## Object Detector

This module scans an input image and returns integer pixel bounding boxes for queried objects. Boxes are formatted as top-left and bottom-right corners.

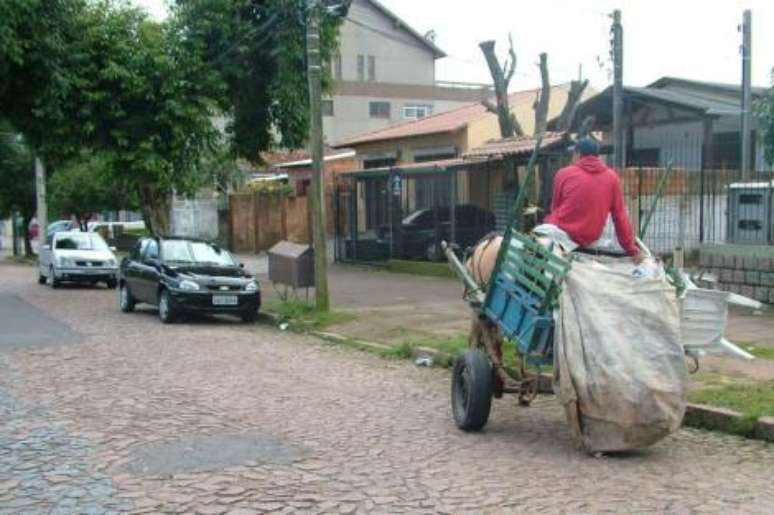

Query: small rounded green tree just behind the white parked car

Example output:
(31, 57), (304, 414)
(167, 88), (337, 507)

(46, 153), (137, 231)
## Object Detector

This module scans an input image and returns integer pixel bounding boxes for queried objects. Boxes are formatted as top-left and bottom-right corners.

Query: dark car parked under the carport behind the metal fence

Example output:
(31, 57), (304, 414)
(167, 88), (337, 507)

(378, 204), (496, 261)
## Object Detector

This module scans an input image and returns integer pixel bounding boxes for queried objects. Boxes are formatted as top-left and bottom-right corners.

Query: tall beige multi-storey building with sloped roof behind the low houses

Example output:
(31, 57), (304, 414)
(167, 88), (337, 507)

(323, 0), (491, 144)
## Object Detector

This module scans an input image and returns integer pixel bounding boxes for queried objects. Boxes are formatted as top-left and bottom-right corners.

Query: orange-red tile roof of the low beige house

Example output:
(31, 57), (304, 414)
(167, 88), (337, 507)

(334, 86), (556, 148)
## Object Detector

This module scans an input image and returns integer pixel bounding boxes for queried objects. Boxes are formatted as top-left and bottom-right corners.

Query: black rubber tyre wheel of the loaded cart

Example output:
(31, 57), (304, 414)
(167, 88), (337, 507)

(452, 349), (492, 431)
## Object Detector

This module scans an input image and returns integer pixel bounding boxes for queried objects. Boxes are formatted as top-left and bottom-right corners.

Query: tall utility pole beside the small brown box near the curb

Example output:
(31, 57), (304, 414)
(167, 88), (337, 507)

(306, 0), (330, 311)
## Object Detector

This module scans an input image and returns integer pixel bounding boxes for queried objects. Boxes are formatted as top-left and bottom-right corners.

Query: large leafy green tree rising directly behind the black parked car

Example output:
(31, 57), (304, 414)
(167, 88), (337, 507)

(55, 4), (218, 234)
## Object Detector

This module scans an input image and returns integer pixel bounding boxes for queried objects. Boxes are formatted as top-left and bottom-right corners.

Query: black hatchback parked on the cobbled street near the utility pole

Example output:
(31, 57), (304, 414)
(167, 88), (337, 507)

(119, 238), (261, 323)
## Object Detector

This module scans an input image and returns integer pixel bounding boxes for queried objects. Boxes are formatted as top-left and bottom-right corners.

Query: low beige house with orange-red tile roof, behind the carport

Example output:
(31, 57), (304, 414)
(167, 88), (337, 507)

(330, 84), (591, 232)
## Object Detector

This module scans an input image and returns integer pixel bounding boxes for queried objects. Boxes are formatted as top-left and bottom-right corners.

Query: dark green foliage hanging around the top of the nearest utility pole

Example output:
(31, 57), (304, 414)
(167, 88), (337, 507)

(173, 0), (349, 161)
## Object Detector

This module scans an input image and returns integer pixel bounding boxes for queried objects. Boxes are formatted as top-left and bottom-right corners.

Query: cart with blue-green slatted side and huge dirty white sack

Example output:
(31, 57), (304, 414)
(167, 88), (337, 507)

(442, 139), (760, 452)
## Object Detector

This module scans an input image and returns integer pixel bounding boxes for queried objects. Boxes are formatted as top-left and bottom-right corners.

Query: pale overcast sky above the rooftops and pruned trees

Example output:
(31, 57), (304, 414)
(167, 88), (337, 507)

(134, 0), (774, 89)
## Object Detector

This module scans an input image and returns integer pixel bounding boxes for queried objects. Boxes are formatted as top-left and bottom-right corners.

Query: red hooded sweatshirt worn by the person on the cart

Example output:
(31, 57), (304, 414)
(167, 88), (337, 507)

(544, 156), (639, 256)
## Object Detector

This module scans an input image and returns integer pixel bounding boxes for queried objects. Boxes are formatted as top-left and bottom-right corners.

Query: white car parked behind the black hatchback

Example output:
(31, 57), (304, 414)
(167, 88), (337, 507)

(38, 231), (118, 288)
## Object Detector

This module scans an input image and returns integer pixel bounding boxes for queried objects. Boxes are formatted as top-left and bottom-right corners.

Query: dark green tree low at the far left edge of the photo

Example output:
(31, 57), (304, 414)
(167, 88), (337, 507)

(0, 120), (36, 256)
